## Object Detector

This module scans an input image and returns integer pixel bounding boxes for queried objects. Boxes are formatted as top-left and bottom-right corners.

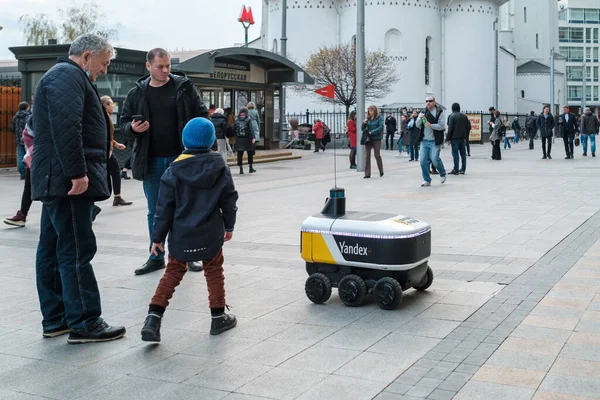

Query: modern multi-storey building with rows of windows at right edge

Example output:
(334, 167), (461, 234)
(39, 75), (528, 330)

(558, 0), (600, 115)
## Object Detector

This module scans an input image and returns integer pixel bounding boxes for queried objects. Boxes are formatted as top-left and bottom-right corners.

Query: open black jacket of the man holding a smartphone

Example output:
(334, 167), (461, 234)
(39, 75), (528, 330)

(120, 73), (208, 180)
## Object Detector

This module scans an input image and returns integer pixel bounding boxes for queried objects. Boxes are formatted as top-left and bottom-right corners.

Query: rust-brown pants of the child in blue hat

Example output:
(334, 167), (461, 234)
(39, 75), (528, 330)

(150, 249), (225, 308)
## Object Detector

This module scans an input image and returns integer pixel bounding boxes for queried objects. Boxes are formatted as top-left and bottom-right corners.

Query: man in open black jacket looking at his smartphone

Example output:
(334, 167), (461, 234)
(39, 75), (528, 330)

(121, 48), (208, 275)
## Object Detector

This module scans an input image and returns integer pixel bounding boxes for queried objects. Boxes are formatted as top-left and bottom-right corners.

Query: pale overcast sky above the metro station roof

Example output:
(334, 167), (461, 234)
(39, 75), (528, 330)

(0, 0), (262, 59)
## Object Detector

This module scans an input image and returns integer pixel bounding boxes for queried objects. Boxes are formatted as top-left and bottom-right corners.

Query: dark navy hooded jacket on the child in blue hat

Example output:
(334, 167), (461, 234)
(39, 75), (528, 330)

(152, 150), (238, 261)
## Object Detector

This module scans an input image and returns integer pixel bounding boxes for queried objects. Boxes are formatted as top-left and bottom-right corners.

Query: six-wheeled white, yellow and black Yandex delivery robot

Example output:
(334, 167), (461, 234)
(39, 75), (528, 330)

(300, 187), (433, 310)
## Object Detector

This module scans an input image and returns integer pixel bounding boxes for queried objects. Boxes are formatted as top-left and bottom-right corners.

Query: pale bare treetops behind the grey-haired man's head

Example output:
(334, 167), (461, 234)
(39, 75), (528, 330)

(19, 2), (119, 45)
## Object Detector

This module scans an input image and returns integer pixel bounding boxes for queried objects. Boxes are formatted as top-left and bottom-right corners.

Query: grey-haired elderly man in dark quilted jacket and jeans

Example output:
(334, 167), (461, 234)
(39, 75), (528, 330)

(31, 34), (125, 343)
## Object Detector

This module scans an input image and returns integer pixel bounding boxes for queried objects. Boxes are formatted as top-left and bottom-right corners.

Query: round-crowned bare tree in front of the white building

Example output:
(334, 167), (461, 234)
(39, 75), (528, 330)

(298, 44), (400, 115)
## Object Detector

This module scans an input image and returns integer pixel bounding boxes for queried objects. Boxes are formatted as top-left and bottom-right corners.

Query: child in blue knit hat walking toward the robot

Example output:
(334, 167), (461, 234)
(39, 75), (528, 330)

(142, 118), (238, 342)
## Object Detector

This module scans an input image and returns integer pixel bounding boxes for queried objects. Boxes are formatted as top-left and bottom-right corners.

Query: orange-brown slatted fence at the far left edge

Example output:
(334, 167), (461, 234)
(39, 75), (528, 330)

(0, 75), (21, 168)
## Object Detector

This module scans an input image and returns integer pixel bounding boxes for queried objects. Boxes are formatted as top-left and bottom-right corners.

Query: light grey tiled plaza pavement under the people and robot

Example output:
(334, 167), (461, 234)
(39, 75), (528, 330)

(0, 139), (600, 400)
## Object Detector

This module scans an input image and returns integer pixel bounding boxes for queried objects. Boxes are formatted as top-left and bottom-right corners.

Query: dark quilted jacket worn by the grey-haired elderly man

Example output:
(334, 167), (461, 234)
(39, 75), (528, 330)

(31, 57), (111, 201)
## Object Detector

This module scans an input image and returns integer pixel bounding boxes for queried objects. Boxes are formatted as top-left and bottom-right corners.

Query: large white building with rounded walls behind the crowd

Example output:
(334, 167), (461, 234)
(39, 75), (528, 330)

(252, 0), (566, 113)
